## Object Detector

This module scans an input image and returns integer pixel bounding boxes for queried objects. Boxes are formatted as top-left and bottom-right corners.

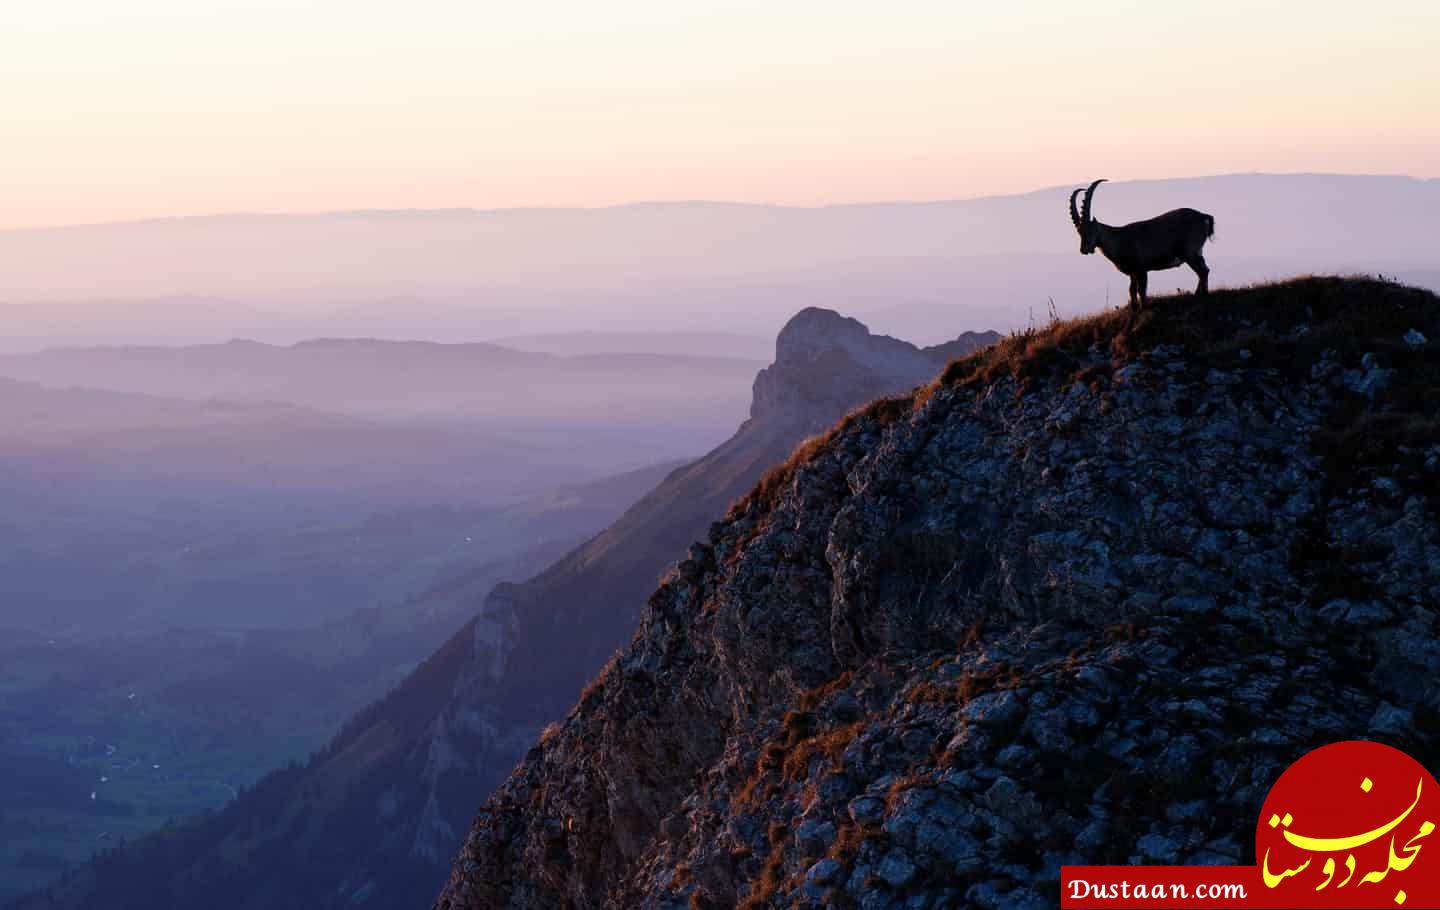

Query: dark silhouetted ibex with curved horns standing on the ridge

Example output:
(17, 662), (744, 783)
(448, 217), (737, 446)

(1070, 179), (1215, 307)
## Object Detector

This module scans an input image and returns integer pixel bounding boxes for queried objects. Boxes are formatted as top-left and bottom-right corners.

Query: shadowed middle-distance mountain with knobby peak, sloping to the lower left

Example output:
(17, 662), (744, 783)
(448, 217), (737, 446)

(23, 308), (996, 910)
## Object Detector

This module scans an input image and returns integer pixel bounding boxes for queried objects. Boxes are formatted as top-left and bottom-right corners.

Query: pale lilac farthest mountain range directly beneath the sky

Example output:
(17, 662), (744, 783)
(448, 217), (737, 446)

(0, 174), (1440, 351)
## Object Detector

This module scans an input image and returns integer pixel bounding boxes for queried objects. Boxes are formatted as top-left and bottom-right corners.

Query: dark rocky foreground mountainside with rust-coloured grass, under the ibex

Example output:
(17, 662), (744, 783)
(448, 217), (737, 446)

(438, 279), (1440, 910)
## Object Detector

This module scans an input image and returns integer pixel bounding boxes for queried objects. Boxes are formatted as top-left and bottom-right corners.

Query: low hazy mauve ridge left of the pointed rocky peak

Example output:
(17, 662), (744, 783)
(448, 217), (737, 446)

(0, 338), (763, 428)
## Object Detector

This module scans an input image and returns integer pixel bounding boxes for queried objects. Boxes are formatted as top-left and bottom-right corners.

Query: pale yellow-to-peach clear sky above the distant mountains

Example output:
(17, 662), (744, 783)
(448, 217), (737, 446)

(0, 0), (1440, 228)
